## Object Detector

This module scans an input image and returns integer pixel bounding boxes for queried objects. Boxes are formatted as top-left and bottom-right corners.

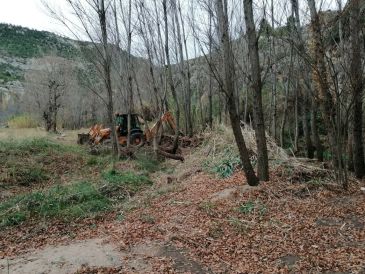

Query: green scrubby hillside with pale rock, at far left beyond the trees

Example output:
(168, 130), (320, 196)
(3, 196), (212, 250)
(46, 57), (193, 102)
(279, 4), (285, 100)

(0, 24), (81, 121)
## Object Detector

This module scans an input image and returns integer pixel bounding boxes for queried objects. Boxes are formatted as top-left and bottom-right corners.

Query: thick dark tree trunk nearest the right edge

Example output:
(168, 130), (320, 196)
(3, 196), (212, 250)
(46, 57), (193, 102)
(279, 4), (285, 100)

(350, 0), (365, 179)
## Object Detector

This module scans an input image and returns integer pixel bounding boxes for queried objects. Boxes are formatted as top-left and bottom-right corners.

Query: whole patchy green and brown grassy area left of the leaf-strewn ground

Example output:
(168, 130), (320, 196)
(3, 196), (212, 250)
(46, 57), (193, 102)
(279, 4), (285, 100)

(0, 135), (155, 227)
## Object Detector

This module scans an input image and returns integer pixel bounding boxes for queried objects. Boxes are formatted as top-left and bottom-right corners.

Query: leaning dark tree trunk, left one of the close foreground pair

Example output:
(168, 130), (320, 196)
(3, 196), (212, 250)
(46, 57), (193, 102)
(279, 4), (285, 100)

(216, 0), (259, 186)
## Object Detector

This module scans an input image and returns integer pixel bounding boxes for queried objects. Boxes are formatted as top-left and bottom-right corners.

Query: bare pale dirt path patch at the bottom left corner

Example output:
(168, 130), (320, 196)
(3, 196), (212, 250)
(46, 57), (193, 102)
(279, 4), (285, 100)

(0, 238), (212, 274)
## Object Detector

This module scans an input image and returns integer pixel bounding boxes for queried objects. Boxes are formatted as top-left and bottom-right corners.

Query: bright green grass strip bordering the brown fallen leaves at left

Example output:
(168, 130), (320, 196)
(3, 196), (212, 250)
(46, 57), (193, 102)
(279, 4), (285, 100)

(0, 170), (152, 227)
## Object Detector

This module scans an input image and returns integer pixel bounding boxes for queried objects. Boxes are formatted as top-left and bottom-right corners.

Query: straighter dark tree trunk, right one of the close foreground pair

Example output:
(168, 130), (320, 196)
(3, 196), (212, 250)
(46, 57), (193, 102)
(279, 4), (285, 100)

(244, 0), (269, 181)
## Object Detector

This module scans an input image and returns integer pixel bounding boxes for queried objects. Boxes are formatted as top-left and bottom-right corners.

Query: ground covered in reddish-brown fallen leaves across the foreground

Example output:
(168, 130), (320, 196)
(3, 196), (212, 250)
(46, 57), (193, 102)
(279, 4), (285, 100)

(0, 165), (365, 273)
